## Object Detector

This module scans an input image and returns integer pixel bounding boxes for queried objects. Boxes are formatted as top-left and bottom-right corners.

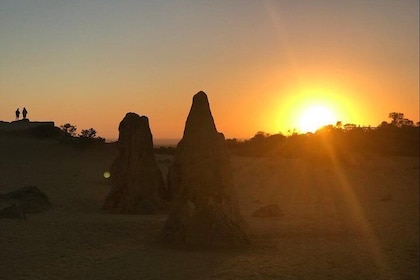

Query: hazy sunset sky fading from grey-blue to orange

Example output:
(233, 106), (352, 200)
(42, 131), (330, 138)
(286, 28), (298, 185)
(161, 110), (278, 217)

(0, 0), (419, 138)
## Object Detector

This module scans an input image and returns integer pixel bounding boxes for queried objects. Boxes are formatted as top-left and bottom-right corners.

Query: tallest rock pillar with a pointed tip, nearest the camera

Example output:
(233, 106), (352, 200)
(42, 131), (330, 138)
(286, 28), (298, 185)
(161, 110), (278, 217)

(161, 91), (249, 247)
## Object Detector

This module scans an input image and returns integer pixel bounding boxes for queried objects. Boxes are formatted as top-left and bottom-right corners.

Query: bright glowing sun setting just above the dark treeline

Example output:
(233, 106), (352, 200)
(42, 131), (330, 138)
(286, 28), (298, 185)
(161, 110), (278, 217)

(299, 105), (337, 133)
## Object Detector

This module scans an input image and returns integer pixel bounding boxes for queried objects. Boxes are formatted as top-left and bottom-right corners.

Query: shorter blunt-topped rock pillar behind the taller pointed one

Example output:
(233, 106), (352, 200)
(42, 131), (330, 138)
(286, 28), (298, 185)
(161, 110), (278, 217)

(103, 113), (165, 214)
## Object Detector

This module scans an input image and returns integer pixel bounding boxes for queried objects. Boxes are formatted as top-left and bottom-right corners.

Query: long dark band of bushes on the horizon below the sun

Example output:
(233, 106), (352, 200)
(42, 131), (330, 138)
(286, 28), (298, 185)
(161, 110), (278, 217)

(226, 113), (420, 160)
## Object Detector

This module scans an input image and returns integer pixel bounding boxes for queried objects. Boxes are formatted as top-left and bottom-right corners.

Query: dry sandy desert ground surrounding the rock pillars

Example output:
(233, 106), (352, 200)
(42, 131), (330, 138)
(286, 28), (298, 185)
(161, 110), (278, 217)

(0, 137), (419, 280)
